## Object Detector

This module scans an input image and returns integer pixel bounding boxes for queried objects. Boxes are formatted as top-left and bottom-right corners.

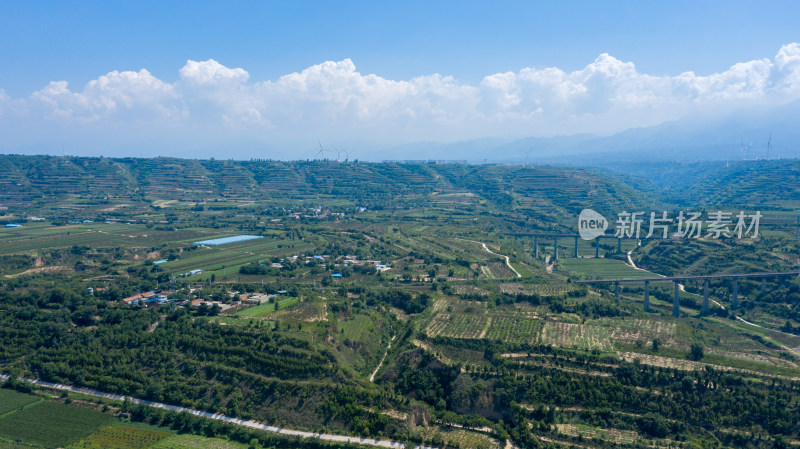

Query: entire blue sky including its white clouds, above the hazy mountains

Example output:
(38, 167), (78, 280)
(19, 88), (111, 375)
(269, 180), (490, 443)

(0, 1), (800, 159)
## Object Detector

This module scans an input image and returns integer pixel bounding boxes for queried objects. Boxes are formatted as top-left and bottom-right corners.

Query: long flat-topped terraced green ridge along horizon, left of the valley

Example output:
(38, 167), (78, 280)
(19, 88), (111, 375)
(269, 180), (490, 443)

(0, 156), (645, 220)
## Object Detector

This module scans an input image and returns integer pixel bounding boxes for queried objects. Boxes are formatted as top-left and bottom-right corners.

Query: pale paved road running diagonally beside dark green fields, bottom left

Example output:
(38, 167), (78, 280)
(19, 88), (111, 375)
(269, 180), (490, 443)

(0, 374), (438, 449)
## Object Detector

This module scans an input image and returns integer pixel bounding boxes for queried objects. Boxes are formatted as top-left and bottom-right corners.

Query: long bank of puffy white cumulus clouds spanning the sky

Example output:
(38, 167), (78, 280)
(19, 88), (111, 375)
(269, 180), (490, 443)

(0, 43), (800, 150)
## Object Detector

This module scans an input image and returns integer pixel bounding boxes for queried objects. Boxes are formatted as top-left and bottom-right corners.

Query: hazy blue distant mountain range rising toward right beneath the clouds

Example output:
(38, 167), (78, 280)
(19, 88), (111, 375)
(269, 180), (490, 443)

(384, 101), (800, 166)
